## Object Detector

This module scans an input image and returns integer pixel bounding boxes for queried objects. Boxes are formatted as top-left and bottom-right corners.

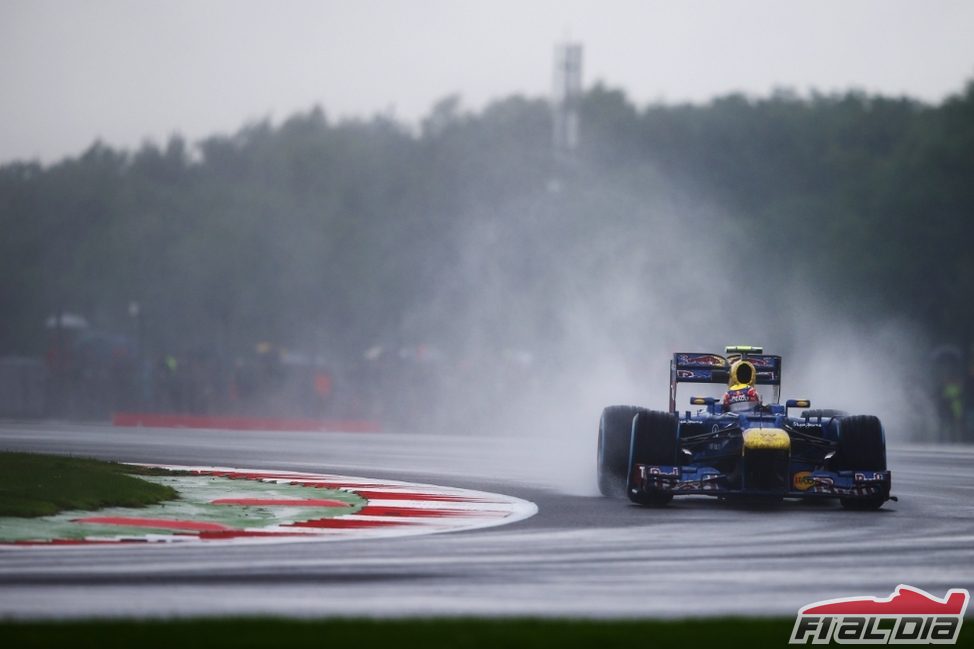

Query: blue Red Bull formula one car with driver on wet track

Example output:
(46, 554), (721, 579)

(598, 346), (896, 509)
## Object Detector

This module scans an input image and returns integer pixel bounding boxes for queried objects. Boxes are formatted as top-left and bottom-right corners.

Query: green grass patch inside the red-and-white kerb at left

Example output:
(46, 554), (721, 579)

(0, 452), (177, 518)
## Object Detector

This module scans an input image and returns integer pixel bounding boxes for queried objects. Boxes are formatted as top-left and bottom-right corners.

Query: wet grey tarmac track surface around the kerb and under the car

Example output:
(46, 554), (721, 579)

(0, 423), (974, 619)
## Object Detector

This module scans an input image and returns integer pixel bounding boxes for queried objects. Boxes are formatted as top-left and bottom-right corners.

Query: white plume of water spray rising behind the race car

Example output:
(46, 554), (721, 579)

(388, 152), (930, 493)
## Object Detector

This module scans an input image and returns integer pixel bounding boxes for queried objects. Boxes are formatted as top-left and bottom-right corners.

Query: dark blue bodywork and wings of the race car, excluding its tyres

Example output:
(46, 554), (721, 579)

(626, 347), (891, 509)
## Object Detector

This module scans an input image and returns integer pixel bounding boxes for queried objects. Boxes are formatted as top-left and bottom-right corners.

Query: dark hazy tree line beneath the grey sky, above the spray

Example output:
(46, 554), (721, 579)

(0, 83), (974, 426)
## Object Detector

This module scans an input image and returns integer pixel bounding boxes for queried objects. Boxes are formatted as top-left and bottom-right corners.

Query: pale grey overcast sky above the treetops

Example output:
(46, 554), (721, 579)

(0, 0), (974, 162)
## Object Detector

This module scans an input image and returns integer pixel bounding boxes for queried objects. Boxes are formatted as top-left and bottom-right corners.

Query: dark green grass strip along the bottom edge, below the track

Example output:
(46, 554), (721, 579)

(0, 618), (793, 649)
